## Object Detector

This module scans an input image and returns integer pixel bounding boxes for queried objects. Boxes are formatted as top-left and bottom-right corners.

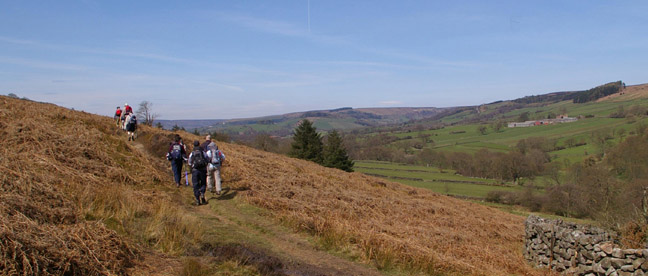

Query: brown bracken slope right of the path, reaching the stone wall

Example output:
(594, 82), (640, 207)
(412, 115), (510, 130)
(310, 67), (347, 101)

(221, 138), (543, 275)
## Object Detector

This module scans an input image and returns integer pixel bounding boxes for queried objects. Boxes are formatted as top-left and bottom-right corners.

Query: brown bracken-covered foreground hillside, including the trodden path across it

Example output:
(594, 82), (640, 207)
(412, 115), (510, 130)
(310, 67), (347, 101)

(0, 97), (544, 275)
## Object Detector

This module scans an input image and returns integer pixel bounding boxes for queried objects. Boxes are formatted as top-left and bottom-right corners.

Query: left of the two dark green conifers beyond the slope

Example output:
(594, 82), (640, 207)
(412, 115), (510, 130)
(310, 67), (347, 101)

(289, 119), (322, 163)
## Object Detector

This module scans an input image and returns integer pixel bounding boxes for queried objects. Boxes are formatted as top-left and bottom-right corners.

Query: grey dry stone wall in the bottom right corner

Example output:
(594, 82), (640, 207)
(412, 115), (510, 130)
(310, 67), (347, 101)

(524, 215), (648, 276)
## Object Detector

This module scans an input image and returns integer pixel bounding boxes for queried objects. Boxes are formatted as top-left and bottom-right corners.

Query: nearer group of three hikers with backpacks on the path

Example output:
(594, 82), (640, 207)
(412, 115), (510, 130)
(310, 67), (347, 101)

(166, 134), (225, 205)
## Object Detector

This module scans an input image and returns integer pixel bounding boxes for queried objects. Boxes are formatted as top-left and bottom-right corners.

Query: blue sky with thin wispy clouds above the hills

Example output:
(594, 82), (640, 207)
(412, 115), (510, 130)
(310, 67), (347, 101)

(0, 0), (648, 119)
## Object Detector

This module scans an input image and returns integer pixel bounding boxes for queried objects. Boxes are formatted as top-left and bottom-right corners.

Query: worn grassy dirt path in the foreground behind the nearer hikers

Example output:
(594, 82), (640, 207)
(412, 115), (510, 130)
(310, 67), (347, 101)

(194, 189), (382, 276)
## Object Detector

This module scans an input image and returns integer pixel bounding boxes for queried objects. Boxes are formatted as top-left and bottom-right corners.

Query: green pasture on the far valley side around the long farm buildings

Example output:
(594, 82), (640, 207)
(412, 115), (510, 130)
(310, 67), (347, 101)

(388, 99), (648, 163)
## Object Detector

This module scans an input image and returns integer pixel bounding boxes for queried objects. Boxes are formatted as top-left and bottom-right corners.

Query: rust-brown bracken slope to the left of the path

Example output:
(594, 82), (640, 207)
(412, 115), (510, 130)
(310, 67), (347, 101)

(0, 96), (200, 275)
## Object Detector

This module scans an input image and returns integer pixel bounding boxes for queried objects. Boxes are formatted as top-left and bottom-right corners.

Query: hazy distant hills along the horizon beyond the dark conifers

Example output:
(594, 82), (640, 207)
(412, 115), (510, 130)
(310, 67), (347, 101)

(160, 107), (446, 136)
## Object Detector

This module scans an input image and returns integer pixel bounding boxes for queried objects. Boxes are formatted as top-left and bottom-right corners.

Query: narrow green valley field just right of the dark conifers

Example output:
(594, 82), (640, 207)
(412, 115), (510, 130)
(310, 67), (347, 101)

(354, 161), (523, 199)
